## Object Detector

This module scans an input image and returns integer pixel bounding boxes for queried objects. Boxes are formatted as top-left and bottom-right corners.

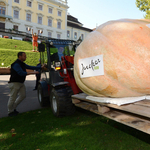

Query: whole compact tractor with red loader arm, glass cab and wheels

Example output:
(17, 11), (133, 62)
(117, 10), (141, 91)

(38, 39), (81, 116)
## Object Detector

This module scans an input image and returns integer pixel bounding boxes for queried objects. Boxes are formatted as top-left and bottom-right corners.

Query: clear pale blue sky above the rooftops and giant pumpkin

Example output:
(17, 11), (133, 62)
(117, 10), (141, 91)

(68, 0), (144, 29)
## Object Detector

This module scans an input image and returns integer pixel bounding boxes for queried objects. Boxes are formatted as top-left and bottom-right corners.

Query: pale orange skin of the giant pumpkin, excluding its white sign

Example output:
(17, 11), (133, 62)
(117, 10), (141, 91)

(74, 19), (150, 97)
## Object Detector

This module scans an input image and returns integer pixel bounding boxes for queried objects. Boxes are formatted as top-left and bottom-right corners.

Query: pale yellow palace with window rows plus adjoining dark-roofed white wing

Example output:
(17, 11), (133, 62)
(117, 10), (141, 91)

(0, 0), (91, 40)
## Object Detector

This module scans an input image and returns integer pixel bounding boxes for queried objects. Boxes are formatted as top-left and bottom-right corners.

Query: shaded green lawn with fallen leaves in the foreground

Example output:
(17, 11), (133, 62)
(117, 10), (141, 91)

(0, 108), (150, 150)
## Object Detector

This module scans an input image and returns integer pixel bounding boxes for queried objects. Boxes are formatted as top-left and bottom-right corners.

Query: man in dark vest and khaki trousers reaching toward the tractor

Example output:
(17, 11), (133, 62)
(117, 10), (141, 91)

(7, 52), (44, 116)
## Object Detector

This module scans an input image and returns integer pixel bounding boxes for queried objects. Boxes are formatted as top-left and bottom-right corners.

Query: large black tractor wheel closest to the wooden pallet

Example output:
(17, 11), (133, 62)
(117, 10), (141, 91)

(50, 87), (75, 117)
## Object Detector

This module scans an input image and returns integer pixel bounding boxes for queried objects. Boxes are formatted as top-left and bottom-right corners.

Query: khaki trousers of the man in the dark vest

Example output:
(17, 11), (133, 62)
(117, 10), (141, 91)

(7, 82), (26, 114)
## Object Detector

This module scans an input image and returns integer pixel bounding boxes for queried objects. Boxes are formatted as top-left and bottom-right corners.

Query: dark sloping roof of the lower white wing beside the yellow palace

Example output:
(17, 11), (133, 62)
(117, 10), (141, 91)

(67, 15), (93, 32)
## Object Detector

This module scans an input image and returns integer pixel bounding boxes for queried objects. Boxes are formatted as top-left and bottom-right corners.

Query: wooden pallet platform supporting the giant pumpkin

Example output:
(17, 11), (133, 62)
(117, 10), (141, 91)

(72, 93), (150, 134)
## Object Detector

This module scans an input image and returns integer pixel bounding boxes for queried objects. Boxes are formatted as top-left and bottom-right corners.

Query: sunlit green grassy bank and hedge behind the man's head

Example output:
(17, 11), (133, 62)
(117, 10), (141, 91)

(0, 38), (40, 67)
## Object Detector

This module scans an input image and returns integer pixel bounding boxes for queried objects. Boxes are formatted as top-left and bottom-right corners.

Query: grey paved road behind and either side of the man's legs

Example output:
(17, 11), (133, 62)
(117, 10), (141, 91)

(0, 75), (42, 118)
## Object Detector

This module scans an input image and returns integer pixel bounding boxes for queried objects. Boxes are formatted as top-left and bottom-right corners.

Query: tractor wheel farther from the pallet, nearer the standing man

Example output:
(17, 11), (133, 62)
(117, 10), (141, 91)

(37, 84), (50, 107)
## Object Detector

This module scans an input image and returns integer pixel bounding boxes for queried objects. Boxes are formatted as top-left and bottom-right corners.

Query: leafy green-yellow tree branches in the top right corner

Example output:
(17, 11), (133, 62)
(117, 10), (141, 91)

(136, 0), (150, 19)
